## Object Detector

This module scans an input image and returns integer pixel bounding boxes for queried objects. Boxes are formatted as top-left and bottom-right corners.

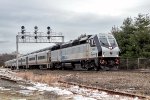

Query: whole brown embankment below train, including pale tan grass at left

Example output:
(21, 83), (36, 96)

(18, 70), (150, 96)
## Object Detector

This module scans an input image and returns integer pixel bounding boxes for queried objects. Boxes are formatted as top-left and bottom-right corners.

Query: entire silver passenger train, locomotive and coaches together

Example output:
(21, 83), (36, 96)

(5, 33), (120, 70)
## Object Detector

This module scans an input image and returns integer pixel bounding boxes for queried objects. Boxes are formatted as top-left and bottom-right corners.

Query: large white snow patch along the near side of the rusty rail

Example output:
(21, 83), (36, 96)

(67, 86), (139, 100)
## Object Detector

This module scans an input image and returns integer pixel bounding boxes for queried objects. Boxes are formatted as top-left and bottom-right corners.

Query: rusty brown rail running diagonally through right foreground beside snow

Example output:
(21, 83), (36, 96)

(58, 81), (150, 100)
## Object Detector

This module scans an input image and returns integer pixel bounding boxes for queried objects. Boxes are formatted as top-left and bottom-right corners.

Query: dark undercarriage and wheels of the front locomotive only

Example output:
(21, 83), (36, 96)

(46, 58), (119, 71)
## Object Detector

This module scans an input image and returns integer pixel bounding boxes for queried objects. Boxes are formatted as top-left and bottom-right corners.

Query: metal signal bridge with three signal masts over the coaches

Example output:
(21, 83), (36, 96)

(16, 26), (64, 69)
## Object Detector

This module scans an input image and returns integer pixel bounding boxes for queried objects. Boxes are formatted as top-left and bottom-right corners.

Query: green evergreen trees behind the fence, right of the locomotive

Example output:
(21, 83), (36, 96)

(111, 14), (150, 58)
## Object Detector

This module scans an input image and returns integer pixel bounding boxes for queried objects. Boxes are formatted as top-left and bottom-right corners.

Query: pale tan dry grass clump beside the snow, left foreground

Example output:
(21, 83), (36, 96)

(17, 72), (59, 85)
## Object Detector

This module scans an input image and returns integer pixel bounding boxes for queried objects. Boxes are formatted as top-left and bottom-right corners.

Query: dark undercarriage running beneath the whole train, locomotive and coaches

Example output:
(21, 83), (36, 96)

(9, 57), (119, 71)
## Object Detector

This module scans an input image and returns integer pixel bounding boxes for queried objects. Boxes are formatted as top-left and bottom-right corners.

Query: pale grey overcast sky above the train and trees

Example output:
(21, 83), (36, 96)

(0, 0), (150, 54)
